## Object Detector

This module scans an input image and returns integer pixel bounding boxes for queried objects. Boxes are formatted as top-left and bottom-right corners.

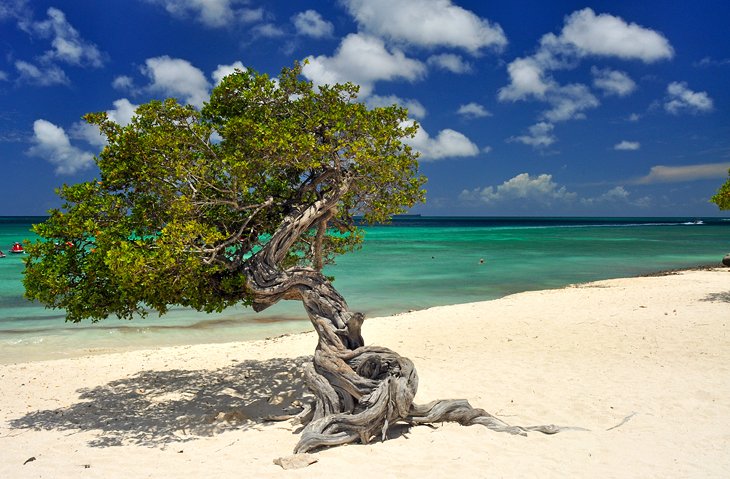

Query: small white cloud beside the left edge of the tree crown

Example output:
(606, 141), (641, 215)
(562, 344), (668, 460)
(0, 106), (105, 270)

(28, 120), (94, 175)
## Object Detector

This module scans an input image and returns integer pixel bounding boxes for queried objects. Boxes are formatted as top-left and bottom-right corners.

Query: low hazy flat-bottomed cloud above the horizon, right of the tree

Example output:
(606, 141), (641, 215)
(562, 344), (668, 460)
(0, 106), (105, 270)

(459, 173), (577, 206)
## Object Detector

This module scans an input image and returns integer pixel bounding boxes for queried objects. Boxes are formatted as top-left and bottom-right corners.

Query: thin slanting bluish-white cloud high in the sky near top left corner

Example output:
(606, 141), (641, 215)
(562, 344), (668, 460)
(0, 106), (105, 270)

(21, 7), (104, 67)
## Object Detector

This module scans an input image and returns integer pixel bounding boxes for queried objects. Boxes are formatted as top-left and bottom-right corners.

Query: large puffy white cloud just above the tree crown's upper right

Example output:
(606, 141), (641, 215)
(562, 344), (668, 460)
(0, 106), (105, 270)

(302, 33), (426, 96)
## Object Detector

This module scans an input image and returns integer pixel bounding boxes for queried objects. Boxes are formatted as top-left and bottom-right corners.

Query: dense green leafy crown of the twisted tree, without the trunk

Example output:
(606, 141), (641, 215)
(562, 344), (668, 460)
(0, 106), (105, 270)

(24, 65), (425, 321)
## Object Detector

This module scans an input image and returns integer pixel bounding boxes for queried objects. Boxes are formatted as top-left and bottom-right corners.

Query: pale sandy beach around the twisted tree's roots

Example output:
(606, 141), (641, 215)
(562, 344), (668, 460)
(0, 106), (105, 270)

(0, 269), (730, 478)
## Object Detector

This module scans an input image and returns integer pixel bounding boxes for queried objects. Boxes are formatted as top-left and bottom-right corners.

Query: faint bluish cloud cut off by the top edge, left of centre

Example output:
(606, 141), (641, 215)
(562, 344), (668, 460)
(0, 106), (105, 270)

(142, 0), (264, 28)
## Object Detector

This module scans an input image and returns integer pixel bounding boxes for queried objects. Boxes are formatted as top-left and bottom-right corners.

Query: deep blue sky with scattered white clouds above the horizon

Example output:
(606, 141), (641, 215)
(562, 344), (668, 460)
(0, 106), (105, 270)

(0, 0), (730, 216)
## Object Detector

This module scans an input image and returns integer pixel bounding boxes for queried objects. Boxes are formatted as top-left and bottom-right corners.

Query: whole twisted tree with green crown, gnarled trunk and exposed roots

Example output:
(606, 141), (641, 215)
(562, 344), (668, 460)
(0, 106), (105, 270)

(24, 65), (559, 452)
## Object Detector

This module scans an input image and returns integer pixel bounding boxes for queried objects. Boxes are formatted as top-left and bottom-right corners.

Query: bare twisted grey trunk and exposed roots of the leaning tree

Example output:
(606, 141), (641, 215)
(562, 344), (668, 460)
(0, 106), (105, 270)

(246, 184), (560, 453)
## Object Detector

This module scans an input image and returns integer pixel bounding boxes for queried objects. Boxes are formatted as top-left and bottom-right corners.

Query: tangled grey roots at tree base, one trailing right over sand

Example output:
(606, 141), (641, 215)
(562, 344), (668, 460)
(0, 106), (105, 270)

(294, 346), (567, 453)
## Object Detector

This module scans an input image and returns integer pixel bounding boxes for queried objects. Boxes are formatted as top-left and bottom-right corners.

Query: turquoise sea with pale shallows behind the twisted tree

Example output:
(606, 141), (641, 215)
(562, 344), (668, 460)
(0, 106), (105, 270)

(0, 215), (730, 364)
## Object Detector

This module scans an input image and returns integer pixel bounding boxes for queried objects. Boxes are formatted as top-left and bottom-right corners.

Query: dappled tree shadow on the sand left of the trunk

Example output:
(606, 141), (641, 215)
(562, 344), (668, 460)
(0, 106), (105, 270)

(10, 356), (312, 447)
